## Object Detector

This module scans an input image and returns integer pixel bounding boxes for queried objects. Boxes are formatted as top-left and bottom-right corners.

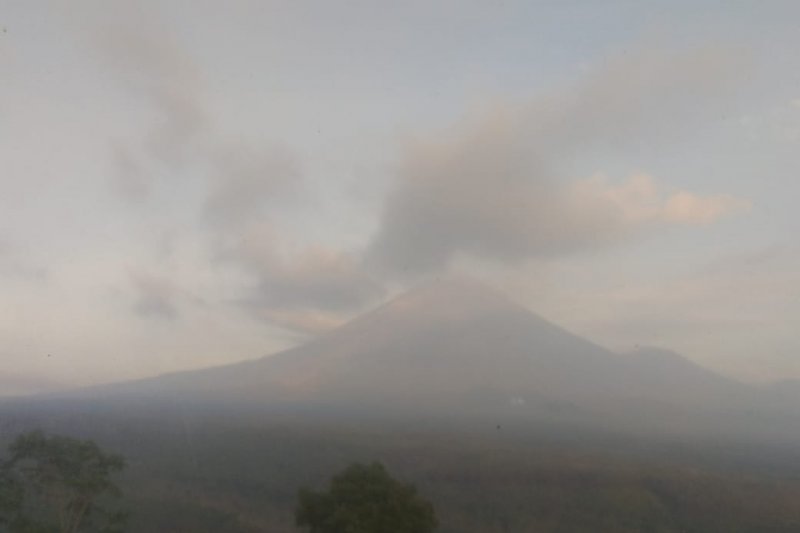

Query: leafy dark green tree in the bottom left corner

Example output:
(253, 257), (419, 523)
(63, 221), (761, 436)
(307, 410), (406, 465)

(0, 431), (125, 533)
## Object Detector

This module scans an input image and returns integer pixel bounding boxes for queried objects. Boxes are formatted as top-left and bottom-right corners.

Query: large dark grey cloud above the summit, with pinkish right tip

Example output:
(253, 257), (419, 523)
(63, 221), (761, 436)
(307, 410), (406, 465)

(367, 50), (746, 275)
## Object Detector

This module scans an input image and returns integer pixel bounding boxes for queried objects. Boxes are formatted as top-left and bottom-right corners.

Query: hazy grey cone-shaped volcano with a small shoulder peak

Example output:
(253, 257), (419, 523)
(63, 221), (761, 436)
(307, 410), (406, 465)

(51, 280), (744, 420)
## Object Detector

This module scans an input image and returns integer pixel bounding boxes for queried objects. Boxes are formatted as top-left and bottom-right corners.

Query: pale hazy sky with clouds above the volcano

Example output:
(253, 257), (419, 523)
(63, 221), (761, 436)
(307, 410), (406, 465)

(0, 0), (800, 394)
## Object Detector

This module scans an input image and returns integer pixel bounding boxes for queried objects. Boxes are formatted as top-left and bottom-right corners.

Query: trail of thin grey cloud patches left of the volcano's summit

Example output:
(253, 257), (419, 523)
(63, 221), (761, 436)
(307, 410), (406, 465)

(92, 17), (381, 331)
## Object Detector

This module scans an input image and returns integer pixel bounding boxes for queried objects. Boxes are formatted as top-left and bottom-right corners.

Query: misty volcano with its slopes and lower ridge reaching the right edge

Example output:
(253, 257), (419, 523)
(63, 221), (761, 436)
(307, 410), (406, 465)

(25, 279), (800, 443)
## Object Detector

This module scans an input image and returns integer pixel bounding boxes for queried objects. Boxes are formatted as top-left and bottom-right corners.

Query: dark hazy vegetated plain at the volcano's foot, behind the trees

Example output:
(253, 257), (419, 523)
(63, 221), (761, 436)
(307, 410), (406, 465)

(0, 415), (800, 533)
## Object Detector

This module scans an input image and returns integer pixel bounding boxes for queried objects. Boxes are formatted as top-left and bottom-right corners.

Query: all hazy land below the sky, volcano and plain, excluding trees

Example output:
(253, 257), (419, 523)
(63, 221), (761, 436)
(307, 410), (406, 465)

(0, 278), (800, 533)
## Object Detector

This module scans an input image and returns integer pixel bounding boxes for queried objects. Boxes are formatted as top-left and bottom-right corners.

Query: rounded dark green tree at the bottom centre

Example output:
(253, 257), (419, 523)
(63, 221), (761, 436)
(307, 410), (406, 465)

(295, 463), (437, 533)
